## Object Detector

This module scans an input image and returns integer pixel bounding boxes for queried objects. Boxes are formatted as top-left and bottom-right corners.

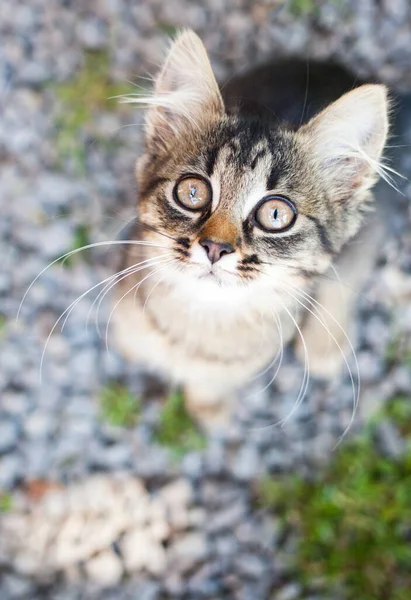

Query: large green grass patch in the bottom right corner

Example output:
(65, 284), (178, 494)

(259, 398), (411, 600)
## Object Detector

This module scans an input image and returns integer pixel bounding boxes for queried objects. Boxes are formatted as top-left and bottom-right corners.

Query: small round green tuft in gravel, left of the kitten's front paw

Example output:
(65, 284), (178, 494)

(100, 383), (141, 427)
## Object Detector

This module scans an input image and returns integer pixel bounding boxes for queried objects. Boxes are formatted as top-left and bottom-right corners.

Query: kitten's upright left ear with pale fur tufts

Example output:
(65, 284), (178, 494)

(142, 30), (224, 148)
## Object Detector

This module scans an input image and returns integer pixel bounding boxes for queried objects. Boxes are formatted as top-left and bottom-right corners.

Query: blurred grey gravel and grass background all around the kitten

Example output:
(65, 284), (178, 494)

(0, 0), (411, 600)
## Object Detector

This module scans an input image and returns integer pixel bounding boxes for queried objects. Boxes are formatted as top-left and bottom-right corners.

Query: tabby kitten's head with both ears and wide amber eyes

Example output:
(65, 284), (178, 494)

(128, 31), (388, 298)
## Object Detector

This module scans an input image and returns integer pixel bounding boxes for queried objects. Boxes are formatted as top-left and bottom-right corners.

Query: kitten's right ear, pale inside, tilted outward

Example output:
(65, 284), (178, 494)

(300, 84), (389, 203)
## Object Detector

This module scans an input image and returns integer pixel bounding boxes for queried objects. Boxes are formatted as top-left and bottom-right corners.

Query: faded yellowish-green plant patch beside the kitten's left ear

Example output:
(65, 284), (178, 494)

(53, 51), (135, 173)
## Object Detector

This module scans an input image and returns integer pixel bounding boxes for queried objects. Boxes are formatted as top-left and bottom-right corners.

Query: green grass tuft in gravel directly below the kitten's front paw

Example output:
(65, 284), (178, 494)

(154, 391), (205, 459)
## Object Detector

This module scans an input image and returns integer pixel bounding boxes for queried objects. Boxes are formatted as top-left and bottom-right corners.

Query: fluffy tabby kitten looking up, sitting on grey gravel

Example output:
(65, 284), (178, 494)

(113, 31), (388, 428)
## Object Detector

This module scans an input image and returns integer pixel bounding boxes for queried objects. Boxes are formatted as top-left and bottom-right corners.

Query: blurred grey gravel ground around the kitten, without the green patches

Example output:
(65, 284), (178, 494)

(0, 0), (411, 600)
